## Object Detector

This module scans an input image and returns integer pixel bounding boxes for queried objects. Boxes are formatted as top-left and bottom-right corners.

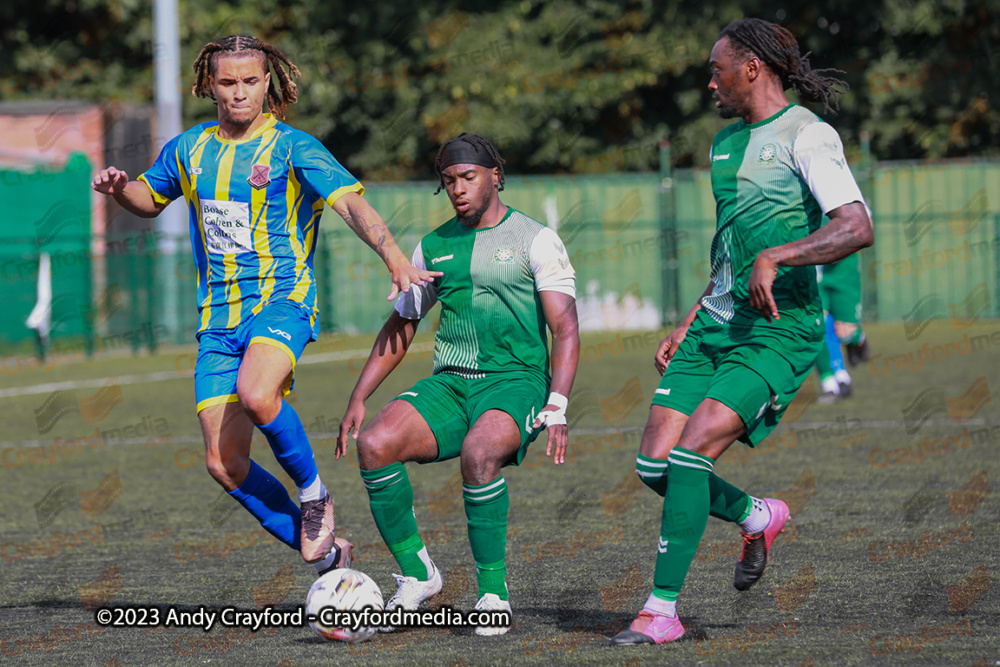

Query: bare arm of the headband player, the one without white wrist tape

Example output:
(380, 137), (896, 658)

(335, 311), (420, 459)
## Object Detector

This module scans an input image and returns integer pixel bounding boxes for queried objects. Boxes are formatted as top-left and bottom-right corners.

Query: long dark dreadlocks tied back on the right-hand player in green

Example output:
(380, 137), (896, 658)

(719, 18), (850, 114)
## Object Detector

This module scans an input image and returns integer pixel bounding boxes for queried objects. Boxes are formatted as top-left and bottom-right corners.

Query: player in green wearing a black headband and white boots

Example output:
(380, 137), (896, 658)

(337, 133), (580, 635)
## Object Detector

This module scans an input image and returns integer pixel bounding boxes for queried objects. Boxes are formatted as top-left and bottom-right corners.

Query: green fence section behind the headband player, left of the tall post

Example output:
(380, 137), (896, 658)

(340, 174), (663, 331)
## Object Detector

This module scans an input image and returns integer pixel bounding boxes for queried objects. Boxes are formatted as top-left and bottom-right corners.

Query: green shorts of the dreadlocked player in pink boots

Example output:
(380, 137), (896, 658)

(653, 310), (824, 447)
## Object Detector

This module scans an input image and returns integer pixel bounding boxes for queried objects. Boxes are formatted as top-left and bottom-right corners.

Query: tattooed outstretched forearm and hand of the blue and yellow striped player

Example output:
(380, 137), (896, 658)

(333, 192), (444, 301)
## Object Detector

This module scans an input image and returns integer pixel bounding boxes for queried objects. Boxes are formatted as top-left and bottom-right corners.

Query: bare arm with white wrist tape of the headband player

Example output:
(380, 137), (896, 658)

(532, 290), (580, 464)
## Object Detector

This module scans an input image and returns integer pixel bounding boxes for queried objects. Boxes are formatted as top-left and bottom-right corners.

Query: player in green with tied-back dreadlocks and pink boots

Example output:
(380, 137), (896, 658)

(611, 19), (873, 644)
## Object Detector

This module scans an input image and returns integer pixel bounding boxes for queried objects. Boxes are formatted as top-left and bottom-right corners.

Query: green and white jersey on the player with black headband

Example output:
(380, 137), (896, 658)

(396, 208), (576, 381)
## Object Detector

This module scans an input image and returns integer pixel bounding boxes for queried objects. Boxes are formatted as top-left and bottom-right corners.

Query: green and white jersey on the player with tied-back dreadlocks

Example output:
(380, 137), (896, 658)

(702, 104), (864, 326)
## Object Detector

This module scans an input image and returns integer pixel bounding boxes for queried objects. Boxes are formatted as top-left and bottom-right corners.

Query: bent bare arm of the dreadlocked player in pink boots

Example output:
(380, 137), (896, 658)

(748, 201), (875, 322)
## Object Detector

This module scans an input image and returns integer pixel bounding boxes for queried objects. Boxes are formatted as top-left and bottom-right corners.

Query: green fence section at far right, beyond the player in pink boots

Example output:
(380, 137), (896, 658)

(862, 159), (1000, 320)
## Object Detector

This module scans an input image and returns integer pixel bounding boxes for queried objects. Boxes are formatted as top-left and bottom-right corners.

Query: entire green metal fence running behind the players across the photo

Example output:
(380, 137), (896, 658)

(0, 155), (1000, 360)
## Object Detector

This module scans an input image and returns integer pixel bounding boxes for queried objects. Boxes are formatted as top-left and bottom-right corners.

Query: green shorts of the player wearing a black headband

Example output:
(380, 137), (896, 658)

(396, 371), (549, 465)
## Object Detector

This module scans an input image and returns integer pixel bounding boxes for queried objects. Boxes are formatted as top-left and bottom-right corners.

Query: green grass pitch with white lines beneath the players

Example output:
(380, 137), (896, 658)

(0, 322), (1000, 666)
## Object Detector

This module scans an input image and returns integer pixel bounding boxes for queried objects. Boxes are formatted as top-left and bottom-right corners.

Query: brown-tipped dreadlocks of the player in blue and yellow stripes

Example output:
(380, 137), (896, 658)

(191, 35), (300, 120)
